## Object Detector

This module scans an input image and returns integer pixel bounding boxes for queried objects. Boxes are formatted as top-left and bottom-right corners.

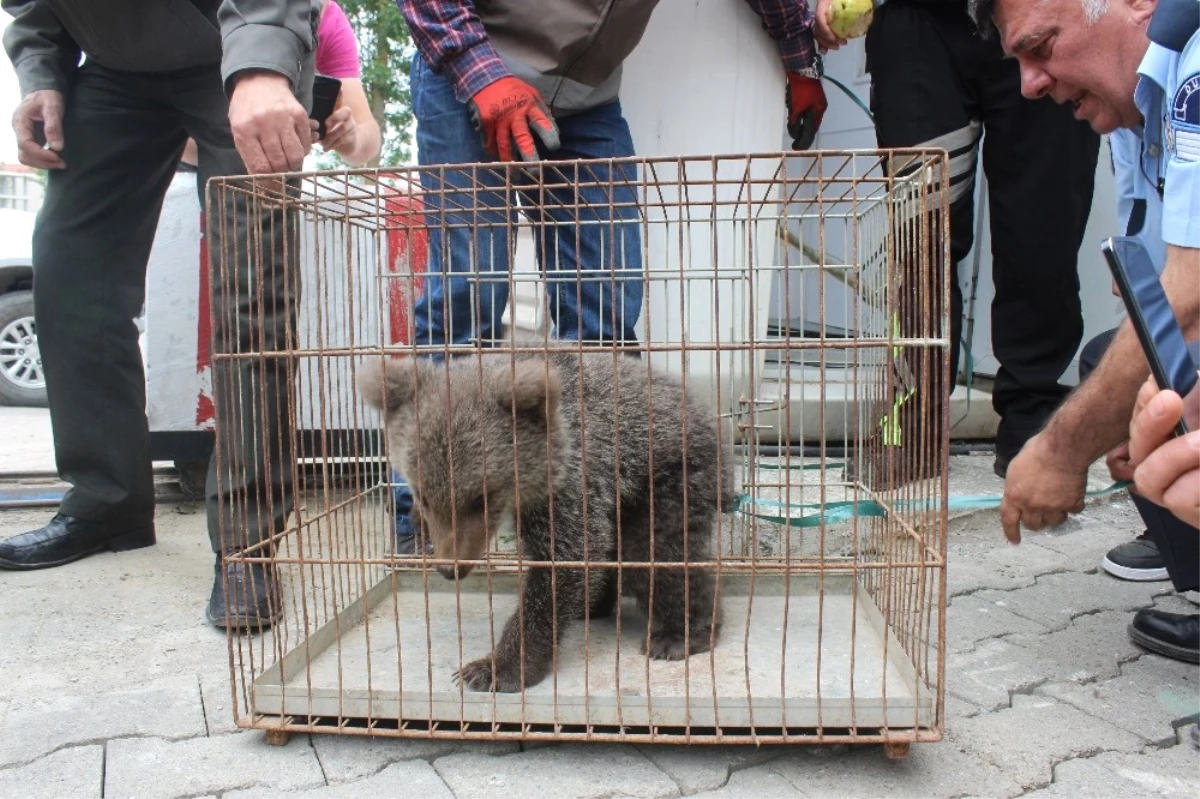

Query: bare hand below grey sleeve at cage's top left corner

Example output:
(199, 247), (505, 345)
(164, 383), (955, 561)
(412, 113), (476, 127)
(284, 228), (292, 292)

(229, 72), (313, 175)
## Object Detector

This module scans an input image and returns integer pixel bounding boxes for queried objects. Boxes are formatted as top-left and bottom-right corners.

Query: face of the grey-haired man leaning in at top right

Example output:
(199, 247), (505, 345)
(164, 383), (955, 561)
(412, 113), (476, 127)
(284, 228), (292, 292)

(995, 0), (1156, 134)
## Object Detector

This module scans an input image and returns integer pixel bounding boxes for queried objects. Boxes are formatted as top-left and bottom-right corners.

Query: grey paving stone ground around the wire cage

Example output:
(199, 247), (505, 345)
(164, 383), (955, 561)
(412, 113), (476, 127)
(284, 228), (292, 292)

(0, 457), (1200, 799)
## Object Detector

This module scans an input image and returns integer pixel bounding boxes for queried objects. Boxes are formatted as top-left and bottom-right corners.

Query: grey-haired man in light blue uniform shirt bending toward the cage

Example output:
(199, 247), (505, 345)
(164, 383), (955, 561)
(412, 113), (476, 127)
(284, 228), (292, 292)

(973, 0), (1200, 662)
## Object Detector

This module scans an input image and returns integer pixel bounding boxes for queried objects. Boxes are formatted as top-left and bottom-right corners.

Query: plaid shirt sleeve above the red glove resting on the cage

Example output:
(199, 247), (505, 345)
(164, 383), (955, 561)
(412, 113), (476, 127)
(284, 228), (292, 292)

(396, 0), (511, 103)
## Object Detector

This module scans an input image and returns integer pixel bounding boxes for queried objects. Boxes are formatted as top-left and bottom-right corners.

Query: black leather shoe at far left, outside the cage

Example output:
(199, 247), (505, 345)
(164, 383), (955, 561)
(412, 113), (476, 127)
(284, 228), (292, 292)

(0, 513), (155, 569)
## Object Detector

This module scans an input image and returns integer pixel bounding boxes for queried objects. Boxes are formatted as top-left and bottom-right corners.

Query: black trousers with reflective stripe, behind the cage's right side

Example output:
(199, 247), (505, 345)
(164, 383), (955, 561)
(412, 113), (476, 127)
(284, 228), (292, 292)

(865, 0), (1100, 456)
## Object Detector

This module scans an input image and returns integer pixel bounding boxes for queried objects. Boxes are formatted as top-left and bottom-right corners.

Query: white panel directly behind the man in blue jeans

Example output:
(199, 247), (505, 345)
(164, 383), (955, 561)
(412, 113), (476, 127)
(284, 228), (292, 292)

(504, 0), (786, 422)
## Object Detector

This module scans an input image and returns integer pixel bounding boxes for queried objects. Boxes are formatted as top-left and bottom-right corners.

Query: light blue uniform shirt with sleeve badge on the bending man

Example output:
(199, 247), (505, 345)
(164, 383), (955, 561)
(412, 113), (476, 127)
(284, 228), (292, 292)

(1134, 19), (1200, 247)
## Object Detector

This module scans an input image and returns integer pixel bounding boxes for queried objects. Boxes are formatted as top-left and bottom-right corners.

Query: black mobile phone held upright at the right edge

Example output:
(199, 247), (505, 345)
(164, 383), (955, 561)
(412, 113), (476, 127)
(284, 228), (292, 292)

(1100, 236), (1196, 435)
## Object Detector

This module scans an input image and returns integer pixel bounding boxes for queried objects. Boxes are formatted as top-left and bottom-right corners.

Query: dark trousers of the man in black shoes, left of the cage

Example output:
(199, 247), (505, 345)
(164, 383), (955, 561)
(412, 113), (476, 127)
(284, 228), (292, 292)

(39, 61), (312, 552)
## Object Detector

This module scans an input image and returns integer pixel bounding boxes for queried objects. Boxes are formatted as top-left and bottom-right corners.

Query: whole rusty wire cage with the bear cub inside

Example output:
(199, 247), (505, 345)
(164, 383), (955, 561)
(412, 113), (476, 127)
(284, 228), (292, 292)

(206, 150), (949, 751)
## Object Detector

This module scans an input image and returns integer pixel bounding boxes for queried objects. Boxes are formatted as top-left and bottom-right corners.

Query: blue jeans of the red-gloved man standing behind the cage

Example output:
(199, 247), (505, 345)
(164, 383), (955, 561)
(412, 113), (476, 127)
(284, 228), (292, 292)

(392, 53), (643, 535)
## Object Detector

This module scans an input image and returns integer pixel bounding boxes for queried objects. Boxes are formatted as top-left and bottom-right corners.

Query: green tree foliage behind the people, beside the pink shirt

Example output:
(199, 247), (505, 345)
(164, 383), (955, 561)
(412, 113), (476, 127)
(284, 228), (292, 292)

(318, 0), (414, 168)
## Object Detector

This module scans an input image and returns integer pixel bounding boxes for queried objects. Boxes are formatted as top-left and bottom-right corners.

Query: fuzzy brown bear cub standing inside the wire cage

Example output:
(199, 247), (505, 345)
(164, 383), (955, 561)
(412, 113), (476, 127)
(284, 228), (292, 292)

(358, 348), (734, 691)
